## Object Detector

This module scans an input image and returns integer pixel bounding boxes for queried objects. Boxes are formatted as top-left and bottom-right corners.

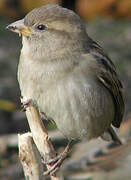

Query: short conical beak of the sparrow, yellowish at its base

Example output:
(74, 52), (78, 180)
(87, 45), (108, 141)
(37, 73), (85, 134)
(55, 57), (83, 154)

(6, 19), (32, 36)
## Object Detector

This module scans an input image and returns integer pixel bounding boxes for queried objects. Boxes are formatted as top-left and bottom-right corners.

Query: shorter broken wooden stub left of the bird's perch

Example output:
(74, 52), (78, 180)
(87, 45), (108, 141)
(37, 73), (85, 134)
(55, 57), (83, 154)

(18, 133), (45, 180)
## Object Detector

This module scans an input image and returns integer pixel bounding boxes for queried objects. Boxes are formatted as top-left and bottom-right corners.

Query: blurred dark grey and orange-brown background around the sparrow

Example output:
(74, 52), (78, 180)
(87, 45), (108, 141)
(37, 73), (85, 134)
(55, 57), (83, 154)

(0, 0), (131, 180)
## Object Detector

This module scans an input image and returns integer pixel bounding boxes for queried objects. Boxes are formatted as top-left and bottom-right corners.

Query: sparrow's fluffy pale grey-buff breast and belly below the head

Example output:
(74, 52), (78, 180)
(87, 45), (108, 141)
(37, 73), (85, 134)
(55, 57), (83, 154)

(18, 46), (114, 139)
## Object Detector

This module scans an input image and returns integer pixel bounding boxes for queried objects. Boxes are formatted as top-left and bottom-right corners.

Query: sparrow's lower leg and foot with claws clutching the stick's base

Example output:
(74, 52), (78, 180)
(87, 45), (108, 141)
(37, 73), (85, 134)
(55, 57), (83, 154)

(44, 140), (73, 175)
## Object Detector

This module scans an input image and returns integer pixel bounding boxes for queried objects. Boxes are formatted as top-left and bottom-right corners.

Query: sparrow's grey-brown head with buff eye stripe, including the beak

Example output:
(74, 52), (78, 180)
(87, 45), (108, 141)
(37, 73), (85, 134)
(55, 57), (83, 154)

(7, 4), (87, 58)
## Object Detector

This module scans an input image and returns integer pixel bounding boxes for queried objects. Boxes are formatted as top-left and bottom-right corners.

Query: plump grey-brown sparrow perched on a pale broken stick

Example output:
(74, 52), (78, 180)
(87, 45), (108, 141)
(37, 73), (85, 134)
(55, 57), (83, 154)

(7, 4), (125, 175)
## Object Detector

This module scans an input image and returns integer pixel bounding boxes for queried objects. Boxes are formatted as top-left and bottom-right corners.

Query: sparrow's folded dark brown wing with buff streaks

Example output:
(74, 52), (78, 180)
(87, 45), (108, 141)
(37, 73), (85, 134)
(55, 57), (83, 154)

(89, 40), (125, 128)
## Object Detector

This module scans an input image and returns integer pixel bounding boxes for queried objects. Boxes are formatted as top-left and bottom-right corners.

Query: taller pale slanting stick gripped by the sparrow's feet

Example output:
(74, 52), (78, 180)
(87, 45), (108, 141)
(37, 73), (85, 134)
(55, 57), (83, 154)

(22, 99), (63, 180)
